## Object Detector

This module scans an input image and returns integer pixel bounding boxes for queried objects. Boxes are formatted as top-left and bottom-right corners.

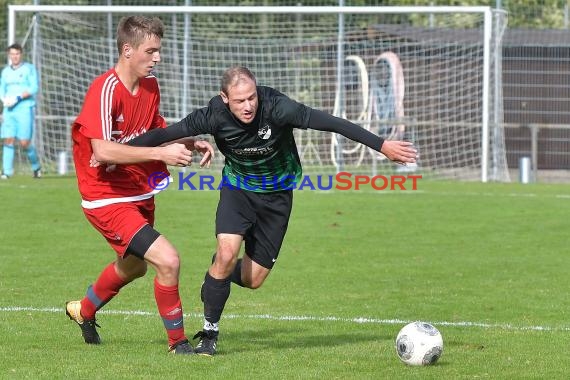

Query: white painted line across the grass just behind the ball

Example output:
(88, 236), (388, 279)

(0, 306), (570, 331)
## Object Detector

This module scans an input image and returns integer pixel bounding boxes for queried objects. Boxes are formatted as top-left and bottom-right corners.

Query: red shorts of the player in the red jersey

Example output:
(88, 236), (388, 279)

(83, 198), (154, 257)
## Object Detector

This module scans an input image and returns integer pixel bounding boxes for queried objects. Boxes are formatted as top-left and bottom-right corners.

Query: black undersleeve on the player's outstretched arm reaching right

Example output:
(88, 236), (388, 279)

(308, 109), (384, 152)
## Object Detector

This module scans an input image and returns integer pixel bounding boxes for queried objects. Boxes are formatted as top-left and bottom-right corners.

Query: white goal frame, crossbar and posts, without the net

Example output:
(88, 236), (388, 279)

(8, 5), (502, 182)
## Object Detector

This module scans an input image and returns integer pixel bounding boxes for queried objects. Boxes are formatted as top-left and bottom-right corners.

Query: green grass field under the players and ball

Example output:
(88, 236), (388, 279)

(0, 176), (570, 379)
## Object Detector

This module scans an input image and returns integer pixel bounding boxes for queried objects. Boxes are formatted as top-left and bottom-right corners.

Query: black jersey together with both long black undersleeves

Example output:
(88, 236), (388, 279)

(128, 86), (384, 193)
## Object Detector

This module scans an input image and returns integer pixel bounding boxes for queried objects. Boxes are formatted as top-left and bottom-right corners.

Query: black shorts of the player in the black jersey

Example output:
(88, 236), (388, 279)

(216, 186), (293, 269)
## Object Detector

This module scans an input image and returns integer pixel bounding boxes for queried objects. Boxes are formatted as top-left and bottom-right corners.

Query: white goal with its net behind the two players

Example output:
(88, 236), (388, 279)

(9, 6), (509, 181)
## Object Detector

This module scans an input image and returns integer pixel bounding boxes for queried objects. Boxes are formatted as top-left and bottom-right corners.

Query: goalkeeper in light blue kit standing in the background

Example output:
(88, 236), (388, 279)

(0, 44), (42, 179)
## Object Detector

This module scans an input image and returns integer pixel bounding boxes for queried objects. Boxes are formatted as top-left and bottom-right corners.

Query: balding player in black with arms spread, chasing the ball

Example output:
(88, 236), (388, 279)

(129, 67), (417, 356)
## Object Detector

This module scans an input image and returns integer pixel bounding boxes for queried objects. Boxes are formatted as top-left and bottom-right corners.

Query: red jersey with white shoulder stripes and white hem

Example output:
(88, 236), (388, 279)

(71, 69), (168, 208)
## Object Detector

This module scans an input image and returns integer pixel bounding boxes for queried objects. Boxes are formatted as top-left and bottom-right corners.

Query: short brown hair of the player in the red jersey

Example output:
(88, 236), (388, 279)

(117, 16), (164, 54)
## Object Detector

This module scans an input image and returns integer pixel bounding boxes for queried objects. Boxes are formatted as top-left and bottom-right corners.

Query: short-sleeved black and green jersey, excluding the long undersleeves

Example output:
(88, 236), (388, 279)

(177, 86), (311, 192)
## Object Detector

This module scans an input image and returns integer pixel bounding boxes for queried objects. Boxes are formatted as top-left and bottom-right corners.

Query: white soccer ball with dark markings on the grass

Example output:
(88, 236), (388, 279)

(396, 321), (443, 365)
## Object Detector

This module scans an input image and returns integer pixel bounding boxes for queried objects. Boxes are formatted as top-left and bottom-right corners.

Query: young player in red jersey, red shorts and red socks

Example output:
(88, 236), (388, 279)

(66, 16), (213, 354)
